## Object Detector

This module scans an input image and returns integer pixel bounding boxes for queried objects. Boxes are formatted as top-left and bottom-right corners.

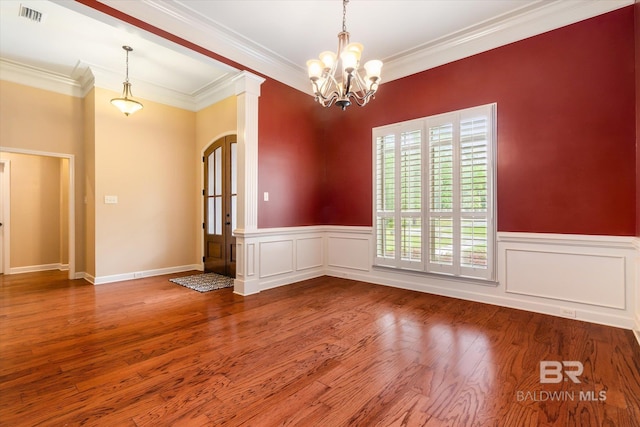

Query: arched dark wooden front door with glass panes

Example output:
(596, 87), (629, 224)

(203, 135), (238, 277)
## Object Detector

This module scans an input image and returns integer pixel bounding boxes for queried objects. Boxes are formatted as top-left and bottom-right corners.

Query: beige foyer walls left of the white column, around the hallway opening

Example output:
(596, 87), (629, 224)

(0, 81), (236, 278)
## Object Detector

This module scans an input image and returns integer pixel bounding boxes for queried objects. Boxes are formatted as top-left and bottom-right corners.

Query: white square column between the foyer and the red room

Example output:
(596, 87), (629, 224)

(233, 71), (264, 295)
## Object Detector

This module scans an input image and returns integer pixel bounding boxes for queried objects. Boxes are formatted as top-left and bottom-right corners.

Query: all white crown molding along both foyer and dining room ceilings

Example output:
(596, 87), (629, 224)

(5, 0), (634, 103)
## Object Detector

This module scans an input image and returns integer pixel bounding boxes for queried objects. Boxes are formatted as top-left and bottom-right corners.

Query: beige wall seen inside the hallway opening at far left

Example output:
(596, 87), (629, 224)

(0, 153), (69, 270)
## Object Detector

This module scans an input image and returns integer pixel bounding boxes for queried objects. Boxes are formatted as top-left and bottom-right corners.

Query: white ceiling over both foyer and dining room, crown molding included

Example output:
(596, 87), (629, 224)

(0, 0), (633, 111)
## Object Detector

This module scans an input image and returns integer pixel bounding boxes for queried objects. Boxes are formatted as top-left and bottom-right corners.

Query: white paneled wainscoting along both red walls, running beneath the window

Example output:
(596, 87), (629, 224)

(235, 226), (640, 336)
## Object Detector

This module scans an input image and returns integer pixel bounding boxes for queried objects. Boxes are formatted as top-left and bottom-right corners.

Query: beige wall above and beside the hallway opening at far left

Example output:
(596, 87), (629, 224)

(0, 81), (84, 271)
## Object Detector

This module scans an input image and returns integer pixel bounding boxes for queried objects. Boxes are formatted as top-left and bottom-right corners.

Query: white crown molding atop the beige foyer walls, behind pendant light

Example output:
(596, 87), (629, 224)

(0, 58), (238, 112)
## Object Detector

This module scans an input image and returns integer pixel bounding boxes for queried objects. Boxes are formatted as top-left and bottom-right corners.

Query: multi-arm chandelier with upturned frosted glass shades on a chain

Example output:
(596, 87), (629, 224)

(307, 0), (382, 110)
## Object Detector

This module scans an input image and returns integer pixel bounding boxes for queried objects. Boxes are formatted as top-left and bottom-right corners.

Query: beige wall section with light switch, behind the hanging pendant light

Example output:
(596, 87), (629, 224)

(95, 88), (198, 277)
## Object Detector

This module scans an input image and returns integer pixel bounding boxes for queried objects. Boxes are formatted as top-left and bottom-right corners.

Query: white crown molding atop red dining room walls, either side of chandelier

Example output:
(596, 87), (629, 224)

(102, 0), (634, 93)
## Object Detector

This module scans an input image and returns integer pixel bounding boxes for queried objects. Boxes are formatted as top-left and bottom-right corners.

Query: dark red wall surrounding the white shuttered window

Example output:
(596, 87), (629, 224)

(322, 5), (638, 235)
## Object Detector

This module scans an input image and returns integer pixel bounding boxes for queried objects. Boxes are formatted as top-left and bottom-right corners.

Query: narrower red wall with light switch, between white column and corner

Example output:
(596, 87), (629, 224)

(258, 79), (325, 228)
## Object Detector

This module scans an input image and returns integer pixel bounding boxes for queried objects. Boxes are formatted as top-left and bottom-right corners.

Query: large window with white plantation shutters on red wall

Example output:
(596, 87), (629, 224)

(373, 104), (496, 280)
